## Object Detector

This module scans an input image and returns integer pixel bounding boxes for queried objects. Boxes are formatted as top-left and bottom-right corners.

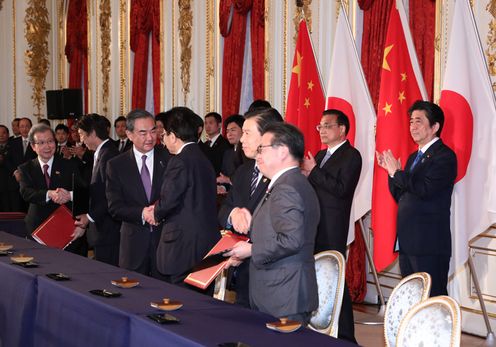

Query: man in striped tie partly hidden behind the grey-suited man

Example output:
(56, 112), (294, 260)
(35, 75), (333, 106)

(219, 108), (283, 307)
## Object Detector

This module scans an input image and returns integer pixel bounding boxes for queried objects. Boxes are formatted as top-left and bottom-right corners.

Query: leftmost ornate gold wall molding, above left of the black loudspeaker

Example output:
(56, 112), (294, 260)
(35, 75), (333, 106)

(24, 0), (50, 117)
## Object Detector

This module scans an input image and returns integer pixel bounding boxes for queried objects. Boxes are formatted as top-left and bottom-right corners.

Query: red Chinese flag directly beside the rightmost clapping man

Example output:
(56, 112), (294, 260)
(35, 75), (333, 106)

(372, 0), (427, 271)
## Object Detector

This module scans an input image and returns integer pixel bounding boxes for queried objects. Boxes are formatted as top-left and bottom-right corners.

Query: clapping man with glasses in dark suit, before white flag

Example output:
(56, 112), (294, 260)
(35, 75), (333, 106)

(302, 109), (362, 343)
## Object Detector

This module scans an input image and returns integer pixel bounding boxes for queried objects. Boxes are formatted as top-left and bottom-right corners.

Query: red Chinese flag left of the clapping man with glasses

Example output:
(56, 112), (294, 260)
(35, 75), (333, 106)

(285, 20), (325, 155)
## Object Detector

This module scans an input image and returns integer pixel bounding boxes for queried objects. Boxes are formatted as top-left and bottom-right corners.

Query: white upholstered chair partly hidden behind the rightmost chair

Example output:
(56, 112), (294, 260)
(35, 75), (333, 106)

(384, 272), (431, 347)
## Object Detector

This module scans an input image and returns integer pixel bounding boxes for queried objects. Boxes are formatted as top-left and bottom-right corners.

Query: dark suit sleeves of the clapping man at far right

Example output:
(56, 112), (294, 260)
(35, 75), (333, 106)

(388, 150), (457, 201)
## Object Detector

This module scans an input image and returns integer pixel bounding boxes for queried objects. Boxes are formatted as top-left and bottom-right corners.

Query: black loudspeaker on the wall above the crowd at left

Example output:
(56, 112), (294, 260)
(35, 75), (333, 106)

(46, 89), (83, 119)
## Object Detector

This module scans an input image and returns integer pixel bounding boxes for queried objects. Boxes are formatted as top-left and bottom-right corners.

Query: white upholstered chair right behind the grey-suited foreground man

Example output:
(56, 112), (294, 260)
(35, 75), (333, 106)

(308, 251), (345, 337)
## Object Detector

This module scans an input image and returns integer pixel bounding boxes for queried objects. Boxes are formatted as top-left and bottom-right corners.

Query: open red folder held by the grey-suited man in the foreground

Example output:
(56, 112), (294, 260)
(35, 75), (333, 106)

(184, 231), (248, 289)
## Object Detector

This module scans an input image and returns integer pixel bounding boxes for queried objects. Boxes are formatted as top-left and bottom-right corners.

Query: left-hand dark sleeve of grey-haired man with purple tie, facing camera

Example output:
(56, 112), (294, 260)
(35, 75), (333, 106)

(105, 158), (146, 224)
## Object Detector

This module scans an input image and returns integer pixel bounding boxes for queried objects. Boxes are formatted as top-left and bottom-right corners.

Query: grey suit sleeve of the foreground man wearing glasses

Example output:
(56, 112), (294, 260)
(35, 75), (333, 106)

(251, 185), (305, 266)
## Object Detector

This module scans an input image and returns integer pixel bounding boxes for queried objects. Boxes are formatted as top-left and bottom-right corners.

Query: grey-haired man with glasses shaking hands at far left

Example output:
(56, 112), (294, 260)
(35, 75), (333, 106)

(19, 124), (87, 256)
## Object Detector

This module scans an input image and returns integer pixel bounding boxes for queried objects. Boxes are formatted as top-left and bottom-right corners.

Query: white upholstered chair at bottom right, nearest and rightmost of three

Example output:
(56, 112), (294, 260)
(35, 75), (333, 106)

(396, 295), (461, 347)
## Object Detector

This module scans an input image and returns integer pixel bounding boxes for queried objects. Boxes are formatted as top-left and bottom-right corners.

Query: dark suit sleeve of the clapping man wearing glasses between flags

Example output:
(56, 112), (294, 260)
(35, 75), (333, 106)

(308, 151), (362, 198)
